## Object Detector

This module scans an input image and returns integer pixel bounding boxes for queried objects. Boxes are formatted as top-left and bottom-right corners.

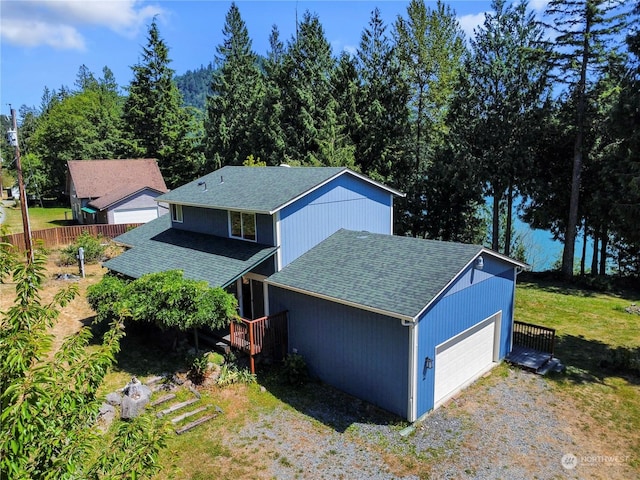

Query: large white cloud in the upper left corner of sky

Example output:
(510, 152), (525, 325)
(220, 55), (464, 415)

(0, 0), (163, 50)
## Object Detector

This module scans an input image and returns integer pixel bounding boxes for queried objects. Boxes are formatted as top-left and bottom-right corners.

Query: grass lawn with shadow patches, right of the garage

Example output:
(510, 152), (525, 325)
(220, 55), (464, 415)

(515, 282), (640, 469)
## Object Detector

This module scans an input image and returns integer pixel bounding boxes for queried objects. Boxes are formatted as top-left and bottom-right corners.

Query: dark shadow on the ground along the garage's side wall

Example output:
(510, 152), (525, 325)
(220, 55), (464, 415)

(257, 365), (408, 433)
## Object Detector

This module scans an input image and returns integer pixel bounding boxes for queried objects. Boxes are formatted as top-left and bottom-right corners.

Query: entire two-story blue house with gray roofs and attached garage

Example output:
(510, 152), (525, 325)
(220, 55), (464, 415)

(105, 167), (526, 421)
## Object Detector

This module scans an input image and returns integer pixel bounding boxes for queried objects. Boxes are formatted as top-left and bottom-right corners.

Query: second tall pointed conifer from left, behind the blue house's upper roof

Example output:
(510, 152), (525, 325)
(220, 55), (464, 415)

(205, 3), (264, 168)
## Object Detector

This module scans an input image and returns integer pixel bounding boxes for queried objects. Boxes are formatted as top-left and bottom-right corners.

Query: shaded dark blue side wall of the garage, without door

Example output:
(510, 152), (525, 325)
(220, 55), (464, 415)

(269, 286), (409, 418)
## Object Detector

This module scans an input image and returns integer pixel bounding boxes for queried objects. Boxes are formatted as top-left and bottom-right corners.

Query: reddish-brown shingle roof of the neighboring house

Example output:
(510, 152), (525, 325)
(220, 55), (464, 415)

(67, 158), (167, 198)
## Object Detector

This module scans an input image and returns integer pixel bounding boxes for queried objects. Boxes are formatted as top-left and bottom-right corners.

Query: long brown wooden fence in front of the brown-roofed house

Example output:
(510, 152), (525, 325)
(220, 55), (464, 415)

(2, 223), (141, 251)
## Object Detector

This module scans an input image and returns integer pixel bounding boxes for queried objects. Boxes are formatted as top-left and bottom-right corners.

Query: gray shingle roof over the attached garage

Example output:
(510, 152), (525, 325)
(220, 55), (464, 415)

(267, 230), (483, 319)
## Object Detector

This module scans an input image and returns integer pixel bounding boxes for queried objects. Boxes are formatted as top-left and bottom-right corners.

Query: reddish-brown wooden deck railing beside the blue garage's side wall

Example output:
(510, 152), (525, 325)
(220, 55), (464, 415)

(230, 310), (287, 373)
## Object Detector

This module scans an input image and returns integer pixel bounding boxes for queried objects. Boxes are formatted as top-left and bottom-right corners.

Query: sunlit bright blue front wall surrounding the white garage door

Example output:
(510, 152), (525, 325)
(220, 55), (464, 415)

(417, 258), (515, 417)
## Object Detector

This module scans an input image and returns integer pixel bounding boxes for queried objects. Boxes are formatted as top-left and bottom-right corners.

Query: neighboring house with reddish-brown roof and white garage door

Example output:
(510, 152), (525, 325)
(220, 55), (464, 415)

(67, 158), (168, 224)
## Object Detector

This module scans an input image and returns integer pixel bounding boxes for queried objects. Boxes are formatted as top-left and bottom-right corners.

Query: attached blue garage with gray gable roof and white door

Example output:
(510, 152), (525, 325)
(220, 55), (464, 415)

(265, 230), (527, 421)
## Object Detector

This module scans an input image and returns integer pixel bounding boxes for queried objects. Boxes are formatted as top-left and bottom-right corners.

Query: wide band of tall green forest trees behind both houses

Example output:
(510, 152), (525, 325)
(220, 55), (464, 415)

(2, 0), (640, 278)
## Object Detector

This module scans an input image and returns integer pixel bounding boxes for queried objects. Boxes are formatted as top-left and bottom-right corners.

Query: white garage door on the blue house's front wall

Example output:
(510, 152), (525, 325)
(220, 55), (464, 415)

(434, 313), (500, 407)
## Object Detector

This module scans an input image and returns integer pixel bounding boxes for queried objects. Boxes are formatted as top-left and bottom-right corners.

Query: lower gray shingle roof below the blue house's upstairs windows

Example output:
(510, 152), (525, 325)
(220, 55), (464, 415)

(104, 215), (277, 287)
